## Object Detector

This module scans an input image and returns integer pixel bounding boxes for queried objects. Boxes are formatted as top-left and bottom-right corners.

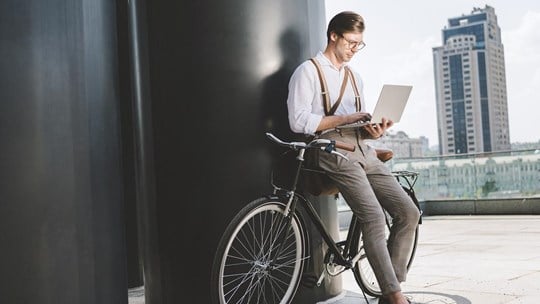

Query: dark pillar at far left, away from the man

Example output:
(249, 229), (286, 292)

(0, 0), (127, 304)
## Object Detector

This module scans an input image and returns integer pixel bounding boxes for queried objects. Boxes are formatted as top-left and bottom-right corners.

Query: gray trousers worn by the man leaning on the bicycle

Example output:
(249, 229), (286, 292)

(318, 129), (420, 295)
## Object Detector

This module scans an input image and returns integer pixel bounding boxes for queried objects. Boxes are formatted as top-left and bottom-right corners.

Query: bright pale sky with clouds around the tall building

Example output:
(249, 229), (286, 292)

(325, 0), (540, 146)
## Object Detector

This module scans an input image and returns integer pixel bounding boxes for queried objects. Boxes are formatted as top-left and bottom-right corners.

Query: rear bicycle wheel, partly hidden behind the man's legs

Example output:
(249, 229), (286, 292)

(353, 210), (420, 297)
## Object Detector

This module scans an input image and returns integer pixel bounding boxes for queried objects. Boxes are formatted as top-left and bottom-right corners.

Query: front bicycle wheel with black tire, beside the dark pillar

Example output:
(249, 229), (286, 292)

(211, 197), (306, 304)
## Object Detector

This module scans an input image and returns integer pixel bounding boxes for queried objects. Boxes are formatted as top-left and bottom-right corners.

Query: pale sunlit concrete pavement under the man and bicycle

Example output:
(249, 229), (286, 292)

(129, 215), (540, 304)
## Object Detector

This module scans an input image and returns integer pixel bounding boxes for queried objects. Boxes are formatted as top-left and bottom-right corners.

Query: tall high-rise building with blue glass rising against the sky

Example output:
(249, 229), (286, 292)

(433, 5), (510, 154)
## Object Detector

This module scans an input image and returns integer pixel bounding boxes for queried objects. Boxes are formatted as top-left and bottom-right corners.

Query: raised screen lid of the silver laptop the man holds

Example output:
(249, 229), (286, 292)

(370, 84), (412, 123)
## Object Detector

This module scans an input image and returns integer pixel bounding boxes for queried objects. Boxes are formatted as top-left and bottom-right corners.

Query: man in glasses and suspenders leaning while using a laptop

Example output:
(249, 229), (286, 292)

(287, 12), (420, 304)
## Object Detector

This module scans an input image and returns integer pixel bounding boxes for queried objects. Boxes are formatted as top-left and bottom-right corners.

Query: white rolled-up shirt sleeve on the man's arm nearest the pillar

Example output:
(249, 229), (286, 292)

(287, 62), (323, 135)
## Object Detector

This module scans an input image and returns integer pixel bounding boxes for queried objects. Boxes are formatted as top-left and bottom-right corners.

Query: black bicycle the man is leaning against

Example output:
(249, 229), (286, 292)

(211, 133), (421, 304)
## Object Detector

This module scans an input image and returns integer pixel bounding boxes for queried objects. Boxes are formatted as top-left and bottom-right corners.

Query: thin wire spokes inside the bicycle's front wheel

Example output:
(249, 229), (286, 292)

(221, 205), (305, 304)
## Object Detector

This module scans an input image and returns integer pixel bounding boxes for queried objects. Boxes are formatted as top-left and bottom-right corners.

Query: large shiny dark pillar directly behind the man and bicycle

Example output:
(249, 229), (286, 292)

(131, 0), (342, 304)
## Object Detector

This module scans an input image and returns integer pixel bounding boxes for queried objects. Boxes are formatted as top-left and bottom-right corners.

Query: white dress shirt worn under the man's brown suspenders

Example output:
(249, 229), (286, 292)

(287, 52), (366, 135)
